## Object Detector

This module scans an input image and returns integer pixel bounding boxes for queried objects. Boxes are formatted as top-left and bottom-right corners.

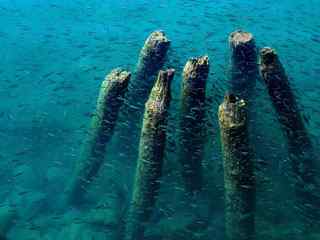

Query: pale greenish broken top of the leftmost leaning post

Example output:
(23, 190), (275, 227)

(103, 68), (131, 89)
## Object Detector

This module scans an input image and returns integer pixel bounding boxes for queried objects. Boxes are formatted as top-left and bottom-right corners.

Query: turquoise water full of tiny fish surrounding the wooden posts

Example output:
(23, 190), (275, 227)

(0, 0), (320, 240)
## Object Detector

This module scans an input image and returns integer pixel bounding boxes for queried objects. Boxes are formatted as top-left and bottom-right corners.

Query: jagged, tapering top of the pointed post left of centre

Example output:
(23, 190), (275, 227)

(146, 69), (175, 114)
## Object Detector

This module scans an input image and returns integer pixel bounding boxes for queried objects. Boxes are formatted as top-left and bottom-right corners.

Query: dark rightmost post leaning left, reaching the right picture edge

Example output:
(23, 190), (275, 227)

(260, 47), (320, 223)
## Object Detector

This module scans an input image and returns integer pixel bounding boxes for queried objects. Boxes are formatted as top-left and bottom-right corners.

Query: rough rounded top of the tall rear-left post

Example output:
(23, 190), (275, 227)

(141, 31), (170, 57)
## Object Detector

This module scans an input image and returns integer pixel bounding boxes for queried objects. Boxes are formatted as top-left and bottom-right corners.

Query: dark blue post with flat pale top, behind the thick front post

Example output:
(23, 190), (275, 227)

(229, 30), (259, 101)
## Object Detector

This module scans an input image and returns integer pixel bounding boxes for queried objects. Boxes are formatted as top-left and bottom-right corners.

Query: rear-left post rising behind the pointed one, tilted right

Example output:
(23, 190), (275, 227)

(121, 31), (170, 160)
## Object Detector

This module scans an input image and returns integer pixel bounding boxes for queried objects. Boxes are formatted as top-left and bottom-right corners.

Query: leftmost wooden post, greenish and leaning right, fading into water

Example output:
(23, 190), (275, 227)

(67, 68), (131, 205)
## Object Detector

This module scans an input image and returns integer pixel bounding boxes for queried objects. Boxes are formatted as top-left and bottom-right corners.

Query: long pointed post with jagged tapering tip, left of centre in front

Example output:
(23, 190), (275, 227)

(125, 69), (174, 240)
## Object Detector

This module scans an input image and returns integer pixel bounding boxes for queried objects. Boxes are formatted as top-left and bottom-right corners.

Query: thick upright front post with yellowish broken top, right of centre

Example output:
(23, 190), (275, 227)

(218, 94), (255, 240)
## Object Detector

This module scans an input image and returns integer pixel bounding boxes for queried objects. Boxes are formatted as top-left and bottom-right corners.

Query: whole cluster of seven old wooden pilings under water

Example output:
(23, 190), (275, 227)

(66, 31), (320, 240)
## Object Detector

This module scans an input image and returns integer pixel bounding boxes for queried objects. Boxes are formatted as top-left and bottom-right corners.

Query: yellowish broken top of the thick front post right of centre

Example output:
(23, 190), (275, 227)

(218, 93), (247, 129)
